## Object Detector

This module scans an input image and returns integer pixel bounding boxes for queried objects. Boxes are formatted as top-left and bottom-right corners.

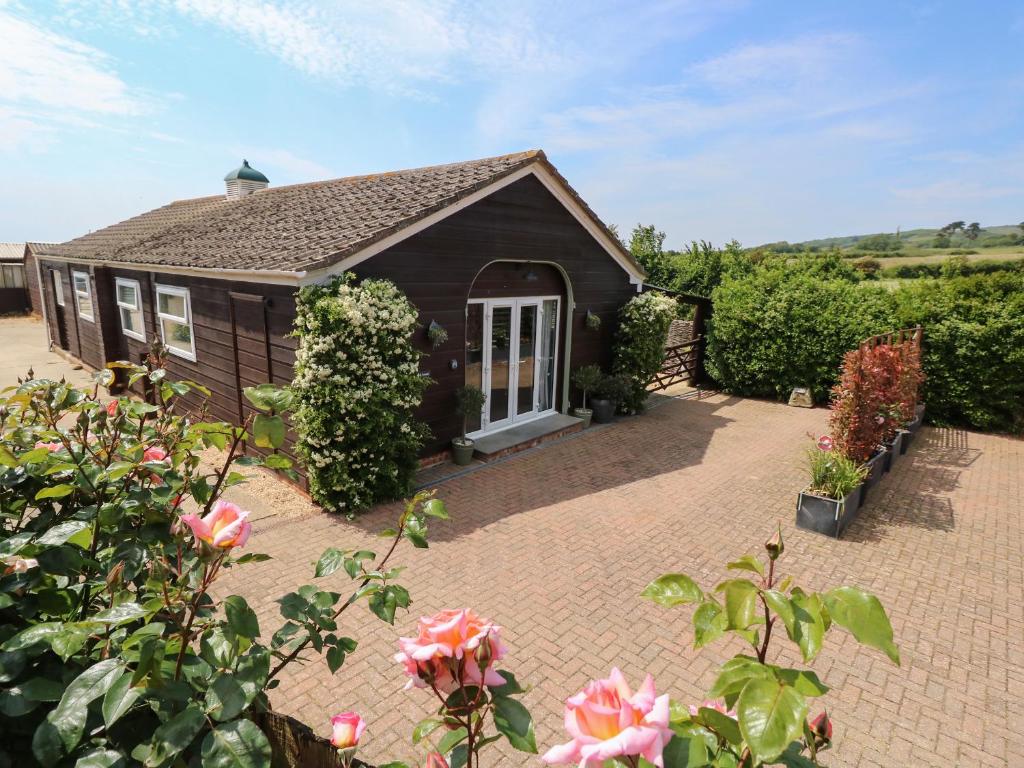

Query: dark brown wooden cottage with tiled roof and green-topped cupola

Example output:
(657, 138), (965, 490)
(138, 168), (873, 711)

(37, 151), (644, 466)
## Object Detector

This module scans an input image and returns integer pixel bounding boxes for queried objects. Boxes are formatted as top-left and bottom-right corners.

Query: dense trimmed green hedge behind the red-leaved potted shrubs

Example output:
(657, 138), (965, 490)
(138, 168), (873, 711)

(708, 264), (1024, 432)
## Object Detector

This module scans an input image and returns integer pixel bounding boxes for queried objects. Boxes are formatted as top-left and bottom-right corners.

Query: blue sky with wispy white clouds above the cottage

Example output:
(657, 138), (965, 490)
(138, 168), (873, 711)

(0, 0), (1024, 247)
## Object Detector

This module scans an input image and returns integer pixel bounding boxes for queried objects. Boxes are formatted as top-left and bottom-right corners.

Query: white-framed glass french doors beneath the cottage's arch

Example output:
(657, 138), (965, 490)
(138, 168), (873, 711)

(466, 296), (560, 435)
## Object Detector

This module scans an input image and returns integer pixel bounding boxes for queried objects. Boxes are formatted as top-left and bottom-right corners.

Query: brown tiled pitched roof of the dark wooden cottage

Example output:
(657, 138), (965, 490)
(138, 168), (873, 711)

(40, 150), (644, 280)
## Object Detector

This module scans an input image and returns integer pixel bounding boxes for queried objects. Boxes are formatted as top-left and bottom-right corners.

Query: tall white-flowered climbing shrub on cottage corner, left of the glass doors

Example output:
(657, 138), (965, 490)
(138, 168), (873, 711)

(292, 274), (429, 515)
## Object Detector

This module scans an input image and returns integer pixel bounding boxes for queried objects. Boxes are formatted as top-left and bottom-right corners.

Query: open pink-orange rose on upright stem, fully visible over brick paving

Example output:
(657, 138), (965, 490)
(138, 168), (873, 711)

(394, 608), (507, 693)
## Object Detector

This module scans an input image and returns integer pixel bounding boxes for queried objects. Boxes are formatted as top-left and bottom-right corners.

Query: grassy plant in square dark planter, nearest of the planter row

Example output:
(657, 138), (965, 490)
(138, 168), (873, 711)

(797, 447), (867, 539)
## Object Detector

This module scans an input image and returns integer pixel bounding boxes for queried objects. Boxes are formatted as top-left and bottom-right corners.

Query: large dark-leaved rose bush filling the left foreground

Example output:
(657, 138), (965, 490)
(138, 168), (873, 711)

(0, 355), (446, 768)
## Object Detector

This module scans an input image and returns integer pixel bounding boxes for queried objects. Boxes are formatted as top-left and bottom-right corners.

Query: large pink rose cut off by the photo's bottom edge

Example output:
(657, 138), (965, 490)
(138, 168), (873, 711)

(542, 669), (672, 768)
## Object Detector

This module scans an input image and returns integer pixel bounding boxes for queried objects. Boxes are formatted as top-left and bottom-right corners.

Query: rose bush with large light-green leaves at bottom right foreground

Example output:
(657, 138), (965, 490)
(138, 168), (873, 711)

(626, 529), (899, 768)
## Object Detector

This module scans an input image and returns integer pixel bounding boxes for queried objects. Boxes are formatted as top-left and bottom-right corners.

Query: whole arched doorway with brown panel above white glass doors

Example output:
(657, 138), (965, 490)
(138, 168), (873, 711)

(465, 261), (568, 436)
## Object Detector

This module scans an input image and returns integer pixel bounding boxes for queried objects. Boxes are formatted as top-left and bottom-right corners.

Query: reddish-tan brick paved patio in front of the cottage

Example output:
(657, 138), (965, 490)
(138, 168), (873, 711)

(218, 395), (1024, 767)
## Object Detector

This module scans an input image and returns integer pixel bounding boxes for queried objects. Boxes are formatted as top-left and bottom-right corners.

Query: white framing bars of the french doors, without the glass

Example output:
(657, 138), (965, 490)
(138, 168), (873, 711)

(467, 295), (562, 437)
